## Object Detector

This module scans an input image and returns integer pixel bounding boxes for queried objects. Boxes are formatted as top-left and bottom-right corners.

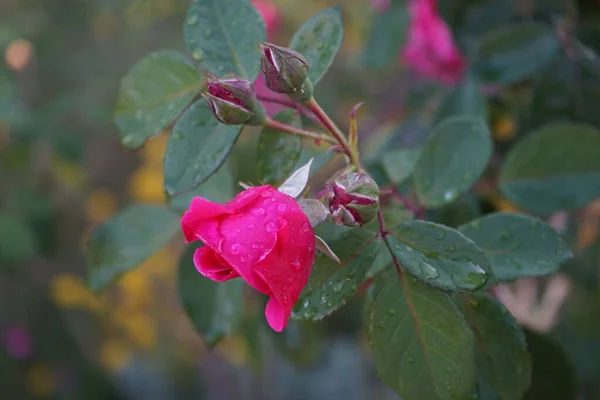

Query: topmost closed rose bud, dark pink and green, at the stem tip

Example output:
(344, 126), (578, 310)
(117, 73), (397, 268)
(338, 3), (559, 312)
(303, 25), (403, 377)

(259, 43), (313, 101)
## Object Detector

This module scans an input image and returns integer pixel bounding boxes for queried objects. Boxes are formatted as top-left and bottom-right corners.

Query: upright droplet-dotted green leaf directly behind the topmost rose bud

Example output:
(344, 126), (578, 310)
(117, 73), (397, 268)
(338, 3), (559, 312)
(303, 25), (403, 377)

(290, 7), (344, 85)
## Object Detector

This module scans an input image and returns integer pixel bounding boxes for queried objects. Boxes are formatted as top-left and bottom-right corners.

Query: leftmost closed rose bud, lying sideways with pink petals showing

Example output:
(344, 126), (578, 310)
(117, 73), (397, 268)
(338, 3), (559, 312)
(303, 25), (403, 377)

(204, 78), (265, 125)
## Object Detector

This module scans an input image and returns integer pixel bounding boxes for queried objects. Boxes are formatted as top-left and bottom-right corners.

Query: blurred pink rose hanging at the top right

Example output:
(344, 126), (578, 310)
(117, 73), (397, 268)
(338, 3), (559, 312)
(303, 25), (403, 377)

(402, 0), (466, 84)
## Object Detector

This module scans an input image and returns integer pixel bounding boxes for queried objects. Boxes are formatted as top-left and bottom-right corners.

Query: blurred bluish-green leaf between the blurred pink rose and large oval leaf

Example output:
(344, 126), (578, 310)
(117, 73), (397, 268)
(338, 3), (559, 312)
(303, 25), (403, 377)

(433, 77), (487, 123)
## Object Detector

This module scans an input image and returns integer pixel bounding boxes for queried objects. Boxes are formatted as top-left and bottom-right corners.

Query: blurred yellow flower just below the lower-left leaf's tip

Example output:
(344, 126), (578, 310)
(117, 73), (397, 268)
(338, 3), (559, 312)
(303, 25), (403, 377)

(50, 274), (102, 311)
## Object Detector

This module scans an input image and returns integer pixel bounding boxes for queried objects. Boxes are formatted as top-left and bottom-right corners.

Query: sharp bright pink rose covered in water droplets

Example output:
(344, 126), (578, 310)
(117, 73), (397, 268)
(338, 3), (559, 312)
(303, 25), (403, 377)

(181, 185), (315, 332)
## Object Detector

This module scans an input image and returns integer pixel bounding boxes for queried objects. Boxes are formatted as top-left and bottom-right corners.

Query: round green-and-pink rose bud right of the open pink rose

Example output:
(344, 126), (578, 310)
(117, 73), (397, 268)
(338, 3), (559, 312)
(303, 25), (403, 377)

(325, 172), (379, 226)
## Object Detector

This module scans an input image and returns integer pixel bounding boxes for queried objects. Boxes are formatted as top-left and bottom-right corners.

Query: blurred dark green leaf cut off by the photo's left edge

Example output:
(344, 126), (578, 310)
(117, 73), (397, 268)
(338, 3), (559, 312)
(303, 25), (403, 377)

(0, 213), (36, 265)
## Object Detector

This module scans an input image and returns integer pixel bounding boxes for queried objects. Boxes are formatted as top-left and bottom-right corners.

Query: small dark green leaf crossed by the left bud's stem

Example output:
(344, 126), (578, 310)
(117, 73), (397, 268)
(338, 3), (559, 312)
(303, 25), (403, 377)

(257, 110), (302, 186)
